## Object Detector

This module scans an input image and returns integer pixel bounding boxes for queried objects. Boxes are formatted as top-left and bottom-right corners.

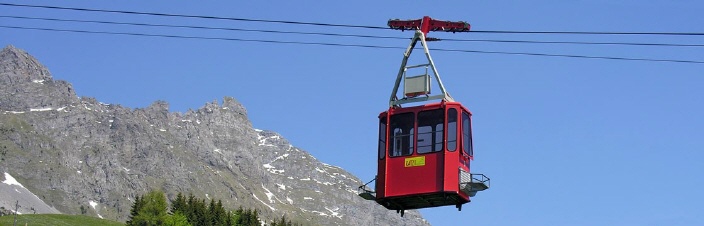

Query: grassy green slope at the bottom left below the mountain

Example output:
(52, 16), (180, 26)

(0, 214), (125, 226)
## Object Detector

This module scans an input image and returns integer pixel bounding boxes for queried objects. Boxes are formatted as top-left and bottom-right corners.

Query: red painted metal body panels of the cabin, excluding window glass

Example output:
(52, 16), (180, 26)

(376, 101), (471, 210)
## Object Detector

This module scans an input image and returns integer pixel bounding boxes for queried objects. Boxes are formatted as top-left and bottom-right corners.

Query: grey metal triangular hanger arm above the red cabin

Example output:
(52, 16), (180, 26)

(389, 30), (454, 107)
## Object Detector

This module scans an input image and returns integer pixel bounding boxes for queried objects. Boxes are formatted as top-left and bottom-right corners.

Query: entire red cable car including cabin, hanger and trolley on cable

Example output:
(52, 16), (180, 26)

(359, 16), (490, 216)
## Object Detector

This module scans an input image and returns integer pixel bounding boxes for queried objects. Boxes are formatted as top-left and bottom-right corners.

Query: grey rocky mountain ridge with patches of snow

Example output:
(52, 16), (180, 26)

(0, 46), (428, 225)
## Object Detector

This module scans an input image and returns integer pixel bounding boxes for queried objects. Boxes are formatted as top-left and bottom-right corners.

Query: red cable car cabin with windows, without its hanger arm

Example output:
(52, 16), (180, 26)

(375, 101), (486, 210)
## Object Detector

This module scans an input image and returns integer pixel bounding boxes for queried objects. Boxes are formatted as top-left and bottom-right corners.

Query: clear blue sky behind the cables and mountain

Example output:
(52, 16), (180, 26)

(0, 1), (704, 225)
